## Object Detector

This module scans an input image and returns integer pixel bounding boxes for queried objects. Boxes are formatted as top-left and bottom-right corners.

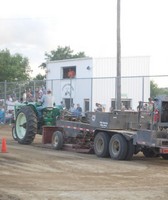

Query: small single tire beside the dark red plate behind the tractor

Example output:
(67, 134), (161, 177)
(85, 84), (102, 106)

(52, 131), (64, 150)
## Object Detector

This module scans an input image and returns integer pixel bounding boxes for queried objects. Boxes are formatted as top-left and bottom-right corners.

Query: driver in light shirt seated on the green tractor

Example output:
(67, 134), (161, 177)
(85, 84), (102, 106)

(37, 89), (55, 117)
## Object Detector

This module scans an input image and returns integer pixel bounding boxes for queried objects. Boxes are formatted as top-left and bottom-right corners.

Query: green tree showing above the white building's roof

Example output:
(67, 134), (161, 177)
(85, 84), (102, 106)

(39, 46), (86, 69)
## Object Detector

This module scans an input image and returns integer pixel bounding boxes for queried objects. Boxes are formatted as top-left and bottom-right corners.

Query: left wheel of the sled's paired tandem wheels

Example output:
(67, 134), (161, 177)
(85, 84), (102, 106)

(94, 132), (110, 157)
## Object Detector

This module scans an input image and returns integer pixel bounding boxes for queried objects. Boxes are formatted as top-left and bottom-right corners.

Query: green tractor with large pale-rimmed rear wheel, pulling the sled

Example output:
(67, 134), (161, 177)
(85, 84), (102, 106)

(12, 102), (62, 144)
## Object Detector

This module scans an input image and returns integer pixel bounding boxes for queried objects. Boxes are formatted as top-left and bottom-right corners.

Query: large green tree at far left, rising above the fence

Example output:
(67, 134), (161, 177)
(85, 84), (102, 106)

(0, 49), (30, 82)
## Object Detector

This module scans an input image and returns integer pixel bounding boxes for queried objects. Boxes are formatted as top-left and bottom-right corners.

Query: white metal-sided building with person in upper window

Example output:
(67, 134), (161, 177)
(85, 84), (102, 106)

(47, 57), (150, 111)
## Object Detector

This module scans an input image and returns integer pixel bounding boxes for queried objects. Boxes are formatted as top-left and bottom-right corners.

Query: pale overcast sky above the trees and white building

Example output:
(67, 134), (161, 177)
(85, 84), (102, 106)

(0, 0), (168, 85)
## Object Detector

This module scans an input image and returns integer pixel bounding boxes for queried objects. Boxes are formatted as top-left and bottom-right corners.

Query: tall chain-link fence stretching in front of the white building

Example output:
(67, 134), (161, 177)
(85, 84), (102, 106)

(0, 75), (168, 111)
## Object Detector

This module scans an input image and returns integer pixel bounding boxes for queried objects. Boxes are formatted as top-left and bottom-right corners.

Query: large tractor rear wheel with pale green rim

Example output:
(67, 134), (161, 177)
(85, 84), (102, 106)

(15, 106), (37, 144)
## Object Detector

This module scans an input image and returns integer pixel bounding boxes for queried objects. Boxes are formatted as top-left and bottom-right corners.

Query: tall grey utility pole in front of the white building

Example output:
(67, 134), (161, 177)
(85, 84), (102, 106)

(116, 0), (121, 110)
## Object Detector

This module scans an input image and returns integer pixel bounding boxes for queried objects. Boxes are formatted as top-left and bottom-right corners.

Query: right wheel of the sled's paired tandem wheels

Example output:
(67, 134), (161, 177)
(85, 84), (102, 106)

(109, 134), (128, 160)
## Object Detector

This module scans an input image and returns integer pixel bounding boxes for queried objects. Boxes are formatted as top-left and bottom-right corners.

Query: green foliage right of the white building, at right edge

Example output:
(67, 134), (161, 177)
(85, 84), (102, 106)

(150, 80), (168, 97)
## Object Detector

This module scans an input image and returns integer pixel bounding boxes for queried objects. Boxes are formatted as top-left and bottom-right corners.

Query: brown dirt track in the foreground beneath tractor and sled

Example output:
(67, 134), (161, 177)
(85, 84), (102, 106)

(0, 126), (168, 200)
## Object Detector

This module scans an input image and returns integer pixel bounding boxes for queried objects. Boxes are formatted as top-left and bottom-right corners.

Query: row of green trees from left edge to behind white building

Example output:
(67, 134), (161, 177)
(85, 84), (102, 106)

(0, 46), (86, 82)
